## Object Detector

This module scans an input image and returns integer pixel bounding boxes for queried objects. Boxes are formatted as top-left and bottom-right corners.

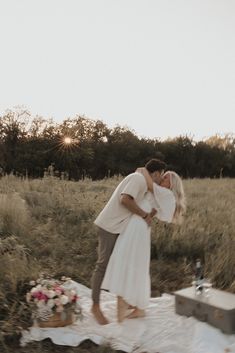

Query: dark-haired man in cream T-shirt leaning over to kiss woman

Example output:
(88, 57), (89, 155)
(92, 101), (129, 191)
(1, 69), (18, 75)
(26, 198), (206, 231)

(91, 159), (166, 325)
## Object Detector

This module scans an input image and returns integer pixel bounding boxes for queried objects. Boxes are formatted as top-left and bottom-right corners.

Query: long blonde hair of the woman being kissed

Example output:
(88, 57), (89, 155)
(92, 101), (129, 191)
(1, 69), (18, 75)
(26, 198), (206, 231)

(165, 170), (186, 224)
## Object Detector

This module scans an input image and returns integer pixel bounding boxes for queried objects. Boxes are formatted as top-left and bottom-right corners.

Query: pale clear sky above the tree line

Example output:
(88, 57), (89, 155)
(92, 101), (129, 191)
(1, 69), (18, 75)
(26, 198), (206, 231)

(0, 0), (235, 140)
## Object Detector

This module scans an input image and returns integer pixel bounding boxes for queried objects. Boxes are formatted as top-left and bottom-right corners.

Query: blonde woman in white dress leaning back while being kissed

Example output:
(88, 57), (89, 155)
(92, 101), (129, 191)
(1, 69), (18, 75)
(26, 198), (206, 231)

(101, 168), (185, 322)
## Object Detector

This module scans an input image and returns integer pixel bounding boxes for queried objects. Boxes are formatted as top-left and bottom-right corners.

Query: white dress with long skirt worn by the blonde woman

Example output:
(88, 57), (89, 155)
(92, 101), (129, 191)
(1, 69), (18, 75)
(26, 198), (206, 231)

(101, 184), (175, 309)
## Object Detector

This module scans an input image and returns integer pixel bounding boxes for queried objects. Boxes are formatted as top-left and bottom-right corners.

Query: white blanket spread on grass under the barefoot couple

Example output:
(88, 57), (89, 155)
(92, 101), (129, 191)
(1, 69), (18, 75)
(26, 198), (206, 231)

(21, 281), (235, 353)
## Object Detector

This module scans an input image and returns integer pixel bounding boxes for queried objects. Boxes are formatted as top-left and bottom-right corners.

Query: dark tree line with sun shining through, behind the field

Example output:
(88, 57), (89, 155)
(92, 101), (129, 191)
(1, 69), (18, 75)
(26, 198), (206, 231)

(0, 108), (235, 180)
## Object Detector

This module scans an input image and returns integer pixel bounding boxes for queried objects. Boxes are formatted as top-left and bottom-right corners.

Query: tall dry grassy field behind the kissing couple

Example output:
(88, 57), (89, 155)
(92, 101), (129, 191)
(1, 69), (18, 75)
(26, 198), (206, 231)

(0, 176), (235, 353)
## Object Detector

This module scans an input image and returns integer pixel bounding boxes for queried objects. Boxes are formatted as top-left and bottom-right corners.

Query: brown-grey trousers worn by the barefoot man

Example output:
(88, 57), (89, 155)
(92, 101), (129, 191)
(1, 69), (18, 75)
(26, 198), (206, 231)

(91, 228), (118, 304)
